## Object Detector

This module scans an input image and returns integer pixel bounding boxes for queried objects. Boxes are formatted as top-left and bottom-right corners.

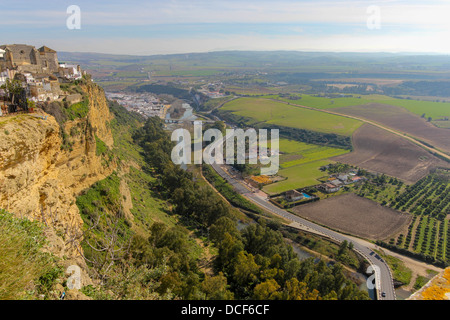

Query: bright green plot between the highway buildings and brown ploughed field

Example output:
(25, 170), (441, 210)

(263, 139), (348, 194)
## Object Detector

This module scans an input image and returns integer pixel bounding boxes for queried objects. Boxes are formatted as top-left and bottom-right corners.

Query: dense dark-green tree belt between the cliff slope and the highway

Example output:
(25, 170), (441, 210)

(130, 118), (368, 300)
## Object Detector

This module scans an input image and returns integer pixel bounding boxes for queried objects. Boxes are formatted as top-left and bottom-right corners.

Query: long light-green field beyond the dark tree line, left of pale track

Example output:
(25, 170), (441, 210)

(221, 98), (362, 136)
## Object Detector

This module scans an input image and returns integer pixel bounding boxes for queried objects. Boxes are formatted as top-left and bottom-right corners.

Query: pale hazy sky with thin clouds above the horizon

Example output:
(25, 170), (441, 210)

(0, 0), (450, 55)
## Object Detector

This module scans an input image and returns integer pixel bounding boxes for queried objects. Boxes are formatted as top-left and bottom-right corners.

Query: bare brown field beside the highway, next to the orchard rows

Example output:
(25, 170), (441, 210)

(292, 193), (411, 240)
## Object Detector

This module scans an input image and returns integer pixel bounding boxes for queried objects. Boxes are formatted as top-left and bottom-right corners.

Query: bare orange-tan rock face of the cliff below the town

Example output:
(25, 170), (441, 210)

(0, 83), (116, 257)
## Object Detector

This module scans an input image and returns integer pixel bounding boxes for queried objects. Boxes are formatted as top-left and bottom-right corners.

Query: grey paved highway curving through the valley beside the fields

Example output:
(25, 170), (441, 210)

(206, 135), (396, 300)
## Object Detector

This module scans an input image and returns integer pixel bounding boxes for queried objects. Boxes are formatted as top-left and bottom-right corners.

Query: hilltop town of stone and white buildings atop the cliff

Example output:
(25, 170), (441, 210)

(0, 44), (86, 115)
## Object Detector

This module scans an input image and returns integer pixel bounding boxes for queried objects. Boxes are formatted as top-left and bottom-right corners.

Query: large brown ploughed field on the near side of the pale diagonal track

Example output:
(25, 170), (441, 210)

(331, 124), (449, 183)
